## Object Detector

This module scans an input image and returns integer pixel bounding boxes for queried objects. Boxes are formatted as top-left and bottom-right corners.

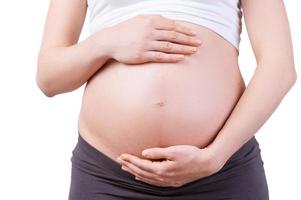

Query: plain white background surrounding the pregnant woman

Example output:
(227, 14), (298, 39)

(0, 0), (301, 200)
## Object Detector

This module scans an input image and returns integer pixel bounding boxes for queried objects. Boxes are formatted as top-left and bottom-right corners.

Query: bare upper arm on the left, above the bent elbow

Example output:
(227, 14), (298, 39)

(41, 0), (87, 50)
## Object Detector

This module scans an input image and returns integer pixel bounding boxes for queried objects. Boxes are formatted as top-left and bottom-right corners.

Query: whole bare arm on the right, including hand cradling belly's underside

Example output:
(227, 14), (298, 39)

(118, 0), (297, 187)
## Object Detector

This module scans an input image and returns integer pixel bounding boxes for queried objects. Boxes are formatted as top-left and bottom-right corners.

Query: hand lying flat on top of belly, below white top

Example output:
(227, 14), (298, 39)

(92, 15), (201, 64)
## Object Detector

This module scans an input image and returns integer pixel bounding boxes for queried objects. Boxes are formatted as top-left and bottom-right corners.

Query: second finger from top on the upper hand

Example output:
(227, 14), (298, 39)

(152, 29), (202, 46)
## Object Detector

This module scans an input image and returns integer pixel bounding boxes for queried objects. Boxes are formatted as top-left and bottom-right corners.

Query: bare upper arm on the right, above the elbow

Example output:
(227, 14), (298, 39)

(241, 0), (294, 67)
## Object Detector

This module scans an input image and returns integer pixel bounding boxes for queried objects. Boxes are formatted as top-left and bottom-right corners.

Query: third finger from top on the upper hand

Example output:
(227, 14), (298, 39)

(147, 41), (197, 54)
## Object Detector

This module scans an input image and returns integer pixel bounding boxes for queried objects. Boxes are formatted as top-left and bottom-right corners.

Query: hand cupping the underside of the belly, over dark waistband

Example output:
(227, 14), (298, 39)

(117, 145), (223, 187)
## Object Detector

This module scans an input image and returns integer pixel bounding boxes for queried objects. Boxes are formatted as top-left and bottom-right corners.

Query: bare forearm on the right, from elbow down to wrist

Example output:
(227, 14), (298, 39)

(208, 60), (296, 164)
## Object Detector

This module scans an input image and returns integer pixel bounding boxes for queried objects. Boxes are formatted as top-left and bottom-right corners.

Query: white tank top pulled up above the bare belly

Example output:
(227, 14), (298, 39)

(87, 0), (242, 50)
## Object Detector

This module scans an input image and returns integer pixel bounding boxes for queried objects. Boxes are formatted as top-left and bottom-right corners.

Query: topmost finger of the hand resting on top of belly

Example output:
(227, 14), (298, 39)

(154, 16), (196, 35)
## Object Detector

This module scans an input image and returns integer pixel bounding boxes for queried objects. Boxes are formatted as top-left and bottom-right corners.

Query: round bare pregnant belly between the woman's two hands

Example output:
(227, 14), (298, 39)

(78, 21), (245, 162)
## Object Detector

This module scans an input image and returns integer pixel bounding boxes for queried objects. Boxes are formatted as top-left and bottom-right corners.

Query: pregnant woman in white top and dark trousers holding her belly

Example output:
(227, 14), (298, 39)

(36, 0), (296, 200)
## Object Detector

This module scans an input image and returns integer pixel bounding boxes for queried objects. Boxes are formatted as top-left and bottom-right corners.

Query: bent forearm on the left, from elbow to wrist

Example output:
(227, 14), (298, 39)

(36, 31), (110, 97)
